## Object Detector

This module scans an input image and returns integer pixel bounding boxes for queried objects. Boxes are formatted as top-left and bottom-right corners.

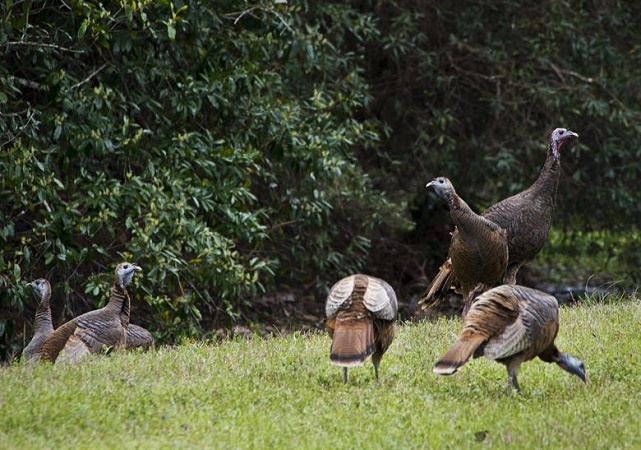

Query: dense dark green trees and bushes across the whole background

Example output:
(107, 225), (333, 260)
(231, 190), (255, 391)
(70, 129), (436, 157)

(0, 0), (641, 357)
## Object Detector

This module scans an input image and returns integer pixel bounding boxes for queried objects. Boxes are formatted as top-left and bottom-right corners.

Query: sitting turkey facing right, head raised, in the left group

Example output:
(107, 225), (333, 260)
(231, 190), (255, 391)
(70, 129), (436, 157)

(42, 262), (142, 363)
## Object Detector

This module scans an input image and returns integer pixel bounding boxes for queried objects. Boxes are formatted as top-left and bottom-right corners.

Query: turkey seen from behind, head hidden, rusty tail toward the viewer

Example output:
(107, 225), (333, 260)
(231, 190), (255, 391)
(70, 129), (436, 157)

(325, 274), (398, 383)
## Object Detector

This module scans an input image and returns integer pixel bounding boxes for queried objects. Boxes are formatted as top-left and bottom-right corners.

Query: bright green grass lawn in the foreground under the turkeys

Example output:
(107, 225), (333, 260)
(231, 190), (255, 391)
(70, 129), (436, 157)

(0, 299), (641, 449)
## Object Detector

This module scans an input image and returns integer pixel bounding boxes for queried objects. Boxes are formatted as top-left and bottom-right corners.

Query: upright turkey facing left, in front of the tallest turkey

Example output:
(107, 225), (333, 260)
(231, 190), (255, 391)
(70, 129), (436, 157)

(426, 177), (508, 315)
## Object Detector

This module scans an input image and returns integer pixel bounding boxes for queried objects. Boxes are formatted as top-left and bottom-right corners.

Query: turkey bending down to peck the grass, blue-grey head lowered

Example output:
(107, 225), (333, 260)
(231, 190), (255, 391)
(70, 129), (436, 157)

(434, 285), (587, 392)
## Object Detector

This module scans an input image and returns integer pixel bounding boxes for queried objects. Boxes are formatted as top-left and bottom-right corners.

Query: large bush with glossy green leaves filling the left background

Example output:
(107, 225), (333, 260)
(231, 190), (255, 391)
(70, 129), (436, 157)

(0, 1), (402, 356)
